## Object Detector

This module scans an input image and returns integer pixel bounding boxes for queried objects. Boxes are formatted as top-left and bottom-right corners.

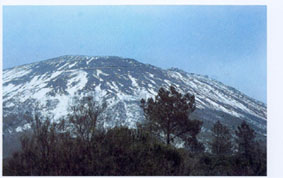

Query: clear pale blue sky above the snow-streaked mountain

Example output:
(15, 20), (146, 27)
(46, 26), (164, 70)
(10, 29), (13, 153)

(3, 6), (267, 103)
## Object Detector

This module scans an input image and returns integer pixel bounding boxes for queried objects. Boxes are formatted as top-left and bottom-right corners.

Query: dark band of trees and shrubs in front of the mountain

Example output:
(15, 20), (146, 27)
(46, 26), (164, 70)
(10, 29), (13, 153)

(3, 87), (266, 176)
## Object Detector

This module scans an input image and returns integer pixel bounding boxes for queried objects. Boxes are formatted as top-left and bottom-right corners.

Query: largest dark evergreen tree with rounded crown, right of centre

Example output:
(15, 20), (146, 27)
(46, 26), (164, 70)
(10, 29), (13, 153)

(141, 86), (202, 145)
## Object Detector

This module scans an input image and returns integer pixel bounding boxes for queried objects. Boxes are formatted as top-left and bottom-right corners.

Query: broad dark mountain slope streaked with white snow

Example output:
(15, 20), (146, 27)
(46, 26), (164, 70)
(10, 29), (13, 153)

(3, 56), (266, 136)
